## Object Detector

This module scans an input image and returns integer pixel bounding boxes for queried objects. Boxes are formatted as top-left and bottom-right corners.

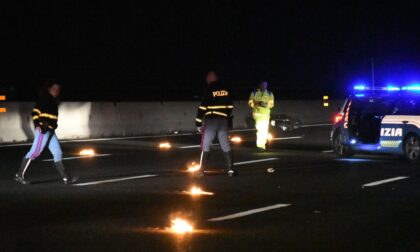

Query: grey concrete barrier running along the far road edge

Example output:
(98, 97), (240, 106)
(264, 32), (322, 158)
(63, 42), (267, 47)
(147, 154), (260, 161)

(0, 100), (341, 143)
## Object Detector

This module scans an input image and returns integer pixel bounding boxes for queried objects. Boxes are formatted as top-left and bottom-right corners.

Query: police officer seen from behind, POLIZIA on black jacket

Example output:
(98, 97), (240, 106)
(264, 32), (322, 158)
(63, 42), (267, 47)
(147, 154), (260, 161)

(195, 71), (237, 176)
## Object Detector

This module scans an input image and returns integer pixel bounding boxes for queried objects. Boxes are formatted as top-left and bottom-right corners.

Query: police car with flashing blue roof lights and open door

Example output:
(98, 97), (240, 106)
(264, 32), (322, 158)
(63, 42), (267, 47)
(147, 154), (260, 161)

(330, 84), (420, 162)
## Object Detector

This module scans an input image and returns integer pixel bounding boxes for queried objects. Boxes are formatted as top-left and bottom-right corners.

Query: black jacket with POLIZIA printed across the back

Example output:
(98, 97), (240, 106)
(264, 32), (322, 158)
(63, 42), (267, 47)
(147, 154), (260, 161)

(195, 82), (233, 127)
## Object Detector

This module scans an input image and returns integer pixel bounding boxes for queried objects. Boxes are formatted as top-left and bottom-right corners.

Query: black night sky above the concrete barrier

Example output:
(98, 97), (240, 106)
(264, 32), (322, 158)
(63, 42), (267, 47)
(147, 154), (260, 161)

(0, 0), (420, 100)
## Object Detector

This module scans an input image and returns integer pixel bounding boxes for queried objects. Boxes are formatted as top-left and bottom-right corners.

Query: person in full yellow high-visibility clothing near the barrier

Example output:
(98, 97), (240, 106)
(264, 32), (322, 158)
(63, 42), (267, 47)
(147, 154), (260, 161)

(248, 81), (274, 150)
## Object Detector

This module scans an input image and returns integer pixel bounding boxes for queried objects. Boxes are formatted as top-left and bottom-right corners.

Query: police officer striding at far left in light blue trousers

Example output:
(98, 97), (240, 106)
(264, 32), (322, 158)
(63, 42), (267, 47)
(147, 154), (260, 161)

(15, 81), (75, 184)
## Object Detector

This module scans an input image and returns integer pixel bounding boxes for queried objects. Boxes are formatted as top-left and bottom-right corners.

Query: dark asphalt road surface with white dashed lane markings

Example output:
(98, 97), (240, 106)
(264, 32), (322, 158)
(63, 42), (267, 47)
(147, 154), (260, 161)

(0, 125), (420, 251)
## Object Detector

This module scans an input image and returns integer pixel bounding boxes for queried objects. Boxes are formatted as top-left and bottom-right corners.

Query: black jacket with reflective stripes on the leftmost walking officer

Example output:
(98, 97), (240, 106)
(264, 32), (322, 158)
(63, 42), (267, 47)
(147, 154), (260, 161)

(32, 93), (58, 133)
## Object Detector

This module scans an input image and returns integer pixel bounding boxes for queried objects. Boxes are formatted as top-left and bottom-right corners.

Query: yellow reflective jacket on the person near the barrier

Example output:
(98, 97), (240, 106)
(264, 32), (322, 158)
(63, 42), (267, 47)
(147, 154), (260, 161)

(248, 89), (274, 116)
